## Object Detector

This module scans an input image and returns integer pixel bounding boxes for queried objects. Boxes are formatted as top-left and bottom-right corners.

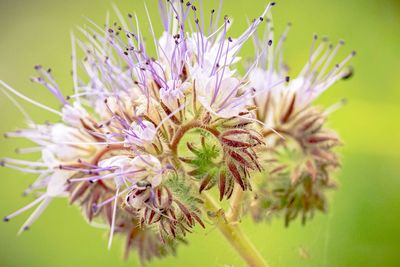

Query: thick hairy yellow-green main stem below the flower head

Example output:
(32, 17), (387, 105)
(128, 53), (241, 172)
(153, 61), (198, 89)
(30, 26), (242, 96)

(203, 192), (268, 267)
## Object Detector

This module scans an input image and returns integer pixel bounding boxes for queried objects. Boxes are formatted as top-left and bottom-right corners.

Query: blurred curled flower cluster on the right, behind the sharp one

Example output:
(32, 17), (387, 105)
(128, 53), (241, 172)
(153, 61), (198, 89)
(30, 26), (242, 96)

(248, 21), (355, 225)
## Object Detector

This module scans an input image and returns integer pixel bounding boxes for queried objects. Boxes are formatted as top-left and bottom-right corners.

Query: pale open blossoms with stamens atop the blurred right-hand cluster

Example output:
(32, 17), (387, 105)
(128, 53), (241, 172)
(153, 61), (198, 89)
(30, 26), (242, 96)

(249, 31), (356, 124)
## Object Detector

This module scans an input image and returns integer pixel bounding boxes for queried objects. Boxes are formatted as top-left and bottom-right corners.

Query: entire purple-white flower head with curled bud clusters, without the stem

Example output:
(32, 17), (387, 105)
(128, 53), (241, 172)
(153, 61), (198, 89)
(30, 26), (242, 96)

(1, 0), (354, 263)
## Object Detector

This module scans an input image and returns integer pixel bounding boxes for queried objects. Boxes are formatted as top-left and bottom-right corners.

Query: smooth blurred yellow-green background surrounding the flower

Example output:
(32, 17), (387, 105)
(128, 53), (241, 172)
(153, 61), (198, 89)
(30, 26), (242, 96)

(0, 0), (400, 267)
